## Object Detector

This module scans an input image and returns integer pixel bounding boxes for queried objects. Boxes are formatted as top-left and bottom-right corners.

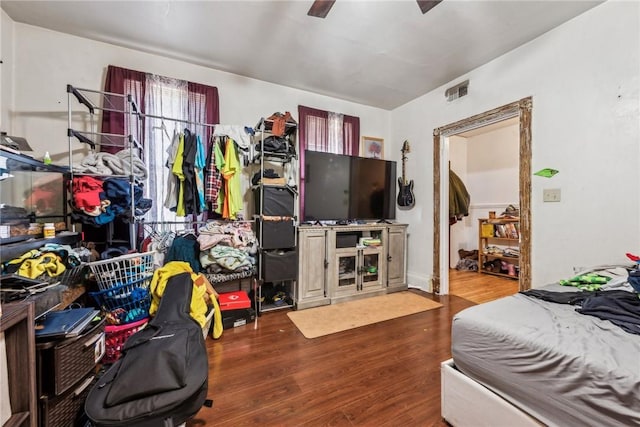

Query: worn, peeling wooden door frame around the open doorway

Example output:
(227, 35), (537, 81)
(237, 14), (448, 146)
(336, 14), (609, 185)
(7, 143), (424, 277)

(432, 97), (533, 295)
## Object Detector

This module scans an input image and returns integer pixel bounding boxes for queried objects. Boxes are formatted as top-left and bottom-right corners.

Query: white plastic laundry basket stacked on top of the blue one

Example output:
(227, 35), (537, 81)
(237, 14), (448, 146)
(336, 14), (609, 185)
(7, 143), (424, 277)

(89, 251), (155, 290)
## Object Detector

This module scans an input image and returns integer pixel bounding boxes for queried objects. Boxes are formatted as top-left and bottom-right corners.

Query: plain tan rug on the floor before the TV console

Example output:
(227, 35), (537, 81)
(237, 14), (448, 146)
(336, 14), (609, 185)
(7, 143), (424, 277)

(287, 291), (442, 338)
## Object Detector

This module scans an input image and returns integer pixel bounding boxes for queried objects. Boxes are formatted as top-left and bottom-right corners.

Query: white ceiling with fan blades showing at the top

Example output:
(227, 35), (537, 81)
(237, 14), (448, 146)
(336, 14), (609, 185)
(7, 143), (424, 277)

(0, 0), (601, 109)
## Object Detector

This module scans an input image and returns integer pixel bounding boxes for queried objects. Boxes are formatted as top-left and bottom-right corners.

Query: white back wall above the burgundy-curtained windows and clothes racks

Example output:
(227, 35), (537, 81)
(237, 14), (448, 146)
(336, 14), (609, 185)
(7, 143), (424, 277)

(2, 21), (390, 160)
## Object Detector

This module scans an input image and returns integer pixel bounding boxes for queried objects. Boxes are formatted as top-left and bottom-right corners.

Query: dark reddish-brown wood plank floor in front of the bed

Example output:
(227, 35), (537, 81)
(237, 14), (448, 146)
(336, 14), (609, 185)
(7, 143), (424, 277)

(188, 274), (516, 427)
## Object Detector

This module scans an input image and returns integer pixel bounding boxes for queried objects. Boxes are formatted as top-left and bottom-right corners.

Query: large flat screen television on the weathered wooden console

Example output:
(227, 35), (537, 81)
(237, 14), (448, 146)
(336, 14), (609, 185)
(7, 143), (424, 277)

(302, 150), (396, 222)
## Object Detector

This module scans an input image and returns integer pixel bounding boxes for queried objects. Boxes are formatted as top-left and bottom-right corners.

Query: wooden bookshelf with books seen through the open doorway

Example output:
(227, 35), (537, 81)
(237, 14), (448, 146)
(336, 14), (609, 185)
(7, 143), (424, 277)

(478, 218), (520, 279)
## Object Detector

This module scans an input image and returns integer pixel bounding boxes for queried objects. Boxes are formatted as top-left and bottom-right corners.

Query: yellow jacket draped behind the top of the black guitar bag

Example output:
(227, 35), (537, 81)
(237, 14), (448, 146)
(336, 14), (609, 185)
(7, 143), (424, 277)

(149, 261), (222, 338)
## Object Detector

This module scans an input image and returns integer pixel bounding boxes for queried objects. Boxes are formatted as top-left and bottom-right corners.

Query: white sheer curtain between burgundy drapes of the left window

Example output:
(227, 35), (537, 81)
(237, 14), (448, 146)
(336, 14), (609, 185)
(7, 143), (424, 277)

(144, 74), (188, 221)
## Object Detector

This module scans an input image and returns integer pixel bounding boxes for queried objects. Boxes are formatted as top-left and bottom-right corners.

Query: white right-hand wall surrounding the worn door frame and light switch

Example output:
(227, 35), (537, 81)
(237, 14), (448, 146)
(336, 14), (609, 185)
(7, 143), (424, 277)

(391, 1), (640, 289)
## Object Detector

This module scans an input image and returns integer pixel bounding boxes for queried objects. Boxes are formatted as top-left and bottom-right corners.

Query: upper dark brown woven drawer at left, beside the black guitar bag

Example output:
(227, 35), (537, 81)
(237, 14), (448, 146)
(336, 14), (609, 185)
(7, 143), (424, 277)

(36, 320), (105, 396)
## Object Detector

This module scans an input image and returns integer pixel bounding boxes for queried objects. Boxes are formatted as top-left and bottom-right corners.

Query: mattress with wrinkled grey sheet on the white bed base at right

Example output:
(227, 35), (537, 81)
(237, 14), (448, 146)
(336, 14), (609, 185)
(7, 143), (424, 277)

(451, 288), (640, 427)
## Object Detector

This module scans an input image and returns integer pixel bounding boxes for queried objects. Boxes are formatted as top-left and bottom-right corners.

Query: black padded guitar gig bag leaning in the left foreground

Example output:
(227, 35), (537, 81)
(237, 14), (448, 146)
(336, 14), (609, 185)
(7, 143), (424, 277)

(85, 273), (211, 427)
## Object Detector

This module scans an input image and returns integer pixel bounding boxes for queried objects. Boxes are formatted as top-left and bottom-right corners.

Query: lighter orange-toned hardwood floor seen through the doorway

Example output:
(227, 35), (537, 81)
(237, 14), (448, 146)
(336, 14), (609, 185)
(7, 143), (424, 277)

(449, 269), (518, 304)
